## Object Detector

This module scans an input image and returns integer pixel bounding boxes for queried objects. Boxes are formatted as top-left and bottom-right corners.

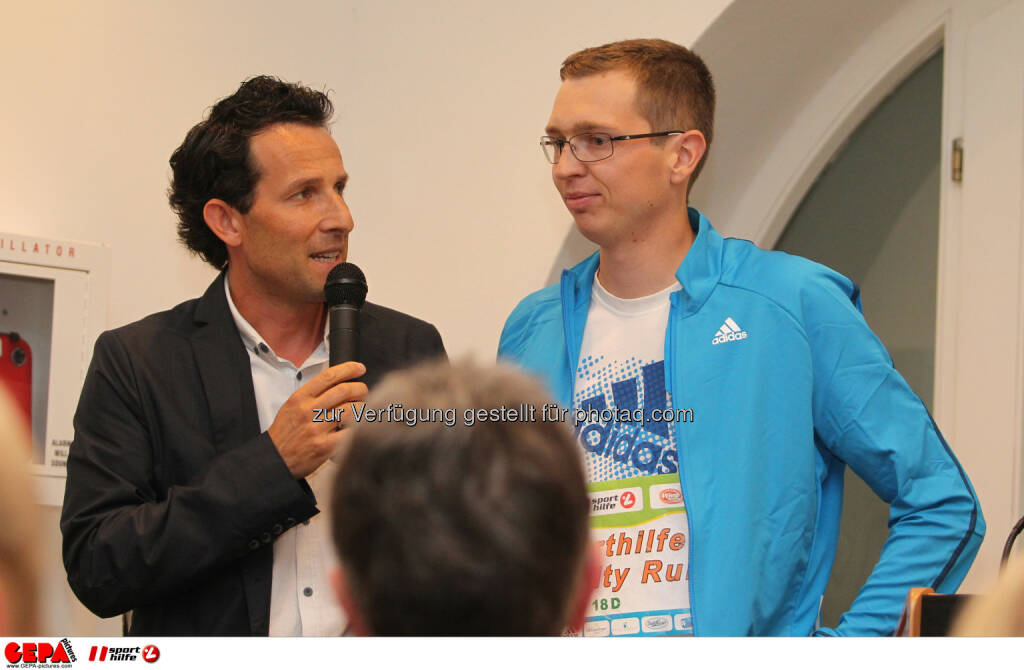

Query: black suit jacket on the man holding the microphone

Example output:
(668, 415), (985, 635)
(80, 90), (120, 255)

(60, 276), (444, 635)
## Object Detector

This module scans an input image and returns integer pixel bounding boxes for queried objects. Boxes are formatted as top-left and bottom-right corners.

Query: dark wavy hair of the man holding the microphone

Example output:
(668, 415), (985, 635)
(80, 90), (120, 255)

(167, 75), (334, 269)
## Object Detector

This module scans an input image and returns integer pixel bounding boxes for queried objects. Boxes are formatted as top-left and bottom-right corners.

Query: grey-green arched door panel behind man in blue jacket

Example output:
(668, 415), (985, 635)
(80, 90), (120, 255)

(775, 51), (942, 626)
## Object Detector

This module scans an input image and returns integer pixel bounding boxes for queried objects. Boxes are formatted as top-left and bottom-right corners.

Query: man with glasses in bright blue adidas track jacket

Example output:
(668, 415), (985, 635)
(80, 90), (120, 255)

(499, 40), (985, 635)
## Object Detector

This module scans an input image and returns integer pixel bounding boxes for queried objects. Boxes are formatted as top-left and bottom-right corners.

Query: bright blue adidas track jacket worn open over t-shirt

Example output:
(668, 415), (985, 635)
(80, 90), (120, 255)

(499, 208), (985, 635)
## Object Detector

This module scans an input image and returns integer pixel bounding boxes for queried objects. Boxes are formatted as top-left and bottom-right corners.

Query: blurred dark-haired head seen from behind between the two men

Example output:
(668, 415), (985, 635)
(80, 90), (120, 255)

(332, 364), (598, 635)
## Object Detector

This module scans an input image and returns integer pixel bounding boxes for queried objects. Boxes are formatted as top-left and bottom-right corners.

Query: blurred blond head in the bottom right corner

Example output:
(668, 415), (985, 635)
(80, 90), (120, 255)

(951, 556), (1024, 637)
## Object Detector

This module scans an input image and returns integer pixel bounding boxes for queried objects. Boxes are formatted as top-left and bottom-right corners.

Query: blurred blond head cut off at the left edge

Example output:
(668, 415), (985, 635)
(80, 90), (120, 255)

(0, 384), (39, 636)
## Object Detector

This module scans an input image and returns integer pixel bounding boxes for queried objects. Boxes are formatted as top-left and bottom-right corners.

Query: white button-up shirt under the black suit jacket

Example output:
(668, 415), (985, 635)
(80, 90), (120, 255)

(224, 276), (345, 636)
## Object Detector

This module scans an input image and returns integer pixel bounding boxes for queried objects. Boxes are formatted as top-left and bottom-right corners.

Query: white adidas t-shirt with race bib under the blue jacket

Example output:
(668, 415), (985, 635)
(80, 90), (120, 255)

(572, 277), (693, 636)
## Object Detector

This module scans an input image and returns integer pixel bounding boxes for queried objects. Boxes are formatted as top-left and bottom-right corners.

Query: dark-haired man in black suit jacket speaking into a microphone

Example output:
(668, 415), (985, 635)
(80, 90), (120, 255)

(60, 77), (444, 635)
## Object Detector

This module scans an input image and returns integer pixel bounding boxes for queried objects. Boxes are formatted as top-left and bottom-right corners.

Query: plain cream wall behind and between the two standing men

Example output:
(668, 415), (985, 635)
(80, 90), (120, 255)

(0, 0), (729, 635)
